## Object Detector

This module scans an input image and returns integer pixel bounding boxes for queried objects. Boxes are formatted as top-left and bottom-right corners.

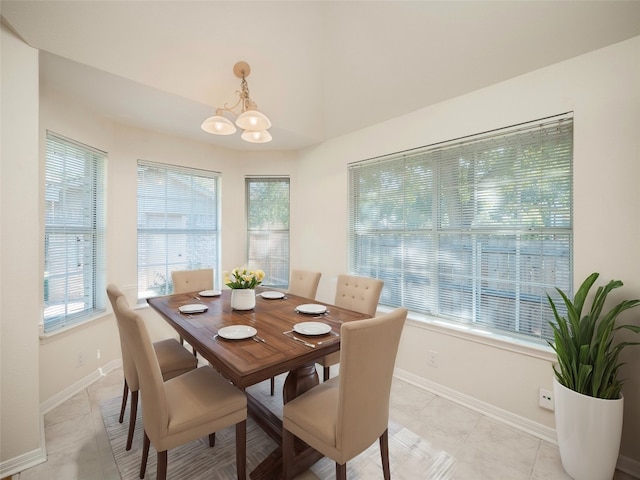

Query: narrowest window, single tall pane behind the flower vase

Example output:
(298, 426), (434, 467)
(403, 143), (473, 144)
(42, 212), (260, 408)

(245, 177), (289, 287)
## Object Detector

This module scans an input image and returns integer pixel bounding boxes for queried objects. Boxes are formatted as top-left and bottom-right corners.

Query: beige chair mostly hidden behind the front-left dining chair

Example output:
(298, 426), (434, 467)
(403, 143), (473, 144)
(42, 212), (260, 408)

(107, 284), (198, 450)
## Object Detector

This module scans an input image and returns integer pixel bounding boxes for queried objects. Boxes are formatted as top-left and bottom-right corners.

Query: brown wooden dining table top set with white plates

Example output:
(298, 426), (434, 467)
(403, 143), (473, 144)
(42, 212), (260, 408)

(147, 288), (368, 388)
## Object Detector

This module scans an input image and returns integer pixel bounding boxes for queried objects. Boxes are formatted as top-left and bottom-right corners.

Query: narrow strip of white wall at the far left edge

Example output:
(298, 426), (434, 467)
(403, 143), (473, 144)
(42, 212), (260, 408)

(0, 24), (44, 468)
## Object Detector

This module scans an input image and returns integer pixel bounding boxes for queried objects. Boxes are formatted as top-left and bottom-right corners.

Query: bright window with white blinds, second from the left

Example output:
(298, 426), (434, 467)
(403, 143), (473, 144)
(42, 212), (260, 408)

(138, 160), (220, 298)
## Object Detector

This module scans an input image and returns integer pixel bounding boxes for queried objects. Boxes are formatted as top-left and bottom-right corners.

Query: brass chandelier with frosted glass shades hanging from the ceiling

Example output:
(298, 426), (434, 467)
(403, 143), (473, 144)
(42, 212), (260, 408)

(201, 62), (271, 143)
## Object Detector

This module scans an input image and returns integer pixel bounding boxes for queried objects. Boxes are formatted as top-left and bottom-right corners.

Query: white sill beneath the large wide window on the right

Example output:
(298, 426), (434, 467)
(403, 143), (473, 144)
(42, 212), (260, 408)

(378, 306), (556, 362)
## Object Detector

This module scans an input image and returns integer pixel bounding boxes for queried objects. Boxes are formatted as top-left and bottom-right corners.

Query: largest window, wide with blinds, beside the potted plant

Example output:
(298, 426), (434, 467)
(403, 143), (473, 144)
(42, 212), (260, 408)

(349, 116), (573, 340)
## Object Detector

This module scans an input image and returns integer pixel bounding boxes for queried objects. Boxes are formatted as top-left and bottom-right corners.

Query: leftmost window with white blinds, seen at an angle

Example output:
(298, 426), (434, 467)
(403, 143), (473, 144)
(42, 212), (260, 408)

(44, 132), (106, 333)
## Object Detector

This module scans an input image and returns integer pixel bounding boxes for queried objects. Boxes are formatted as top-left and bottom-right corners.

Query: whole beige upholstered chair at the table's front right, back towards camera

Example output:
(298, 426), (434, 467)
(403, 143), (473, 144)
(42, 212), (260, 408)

(282, 308), (407, 480)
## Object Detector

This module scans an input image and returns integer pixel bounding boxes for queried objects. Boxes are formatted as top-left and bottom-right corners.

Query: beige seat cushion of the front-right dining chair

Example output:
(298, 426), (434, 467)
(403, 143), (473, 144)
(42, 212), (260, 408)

(283, 377), (340, 450)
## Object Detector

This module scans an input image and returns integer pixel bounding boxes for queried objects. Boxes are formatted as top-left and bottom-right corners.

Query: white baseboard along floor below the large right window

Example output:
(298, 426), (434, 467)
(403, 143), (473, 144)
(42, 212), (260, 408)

(394, 368), (640, 479)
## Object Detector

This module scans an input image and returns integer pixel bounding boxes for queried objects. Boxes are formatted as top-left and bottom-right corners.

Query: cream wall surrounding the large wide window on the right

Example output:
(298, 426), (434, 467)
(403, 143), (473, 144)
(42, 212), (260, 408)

(292, 37), (640, 464)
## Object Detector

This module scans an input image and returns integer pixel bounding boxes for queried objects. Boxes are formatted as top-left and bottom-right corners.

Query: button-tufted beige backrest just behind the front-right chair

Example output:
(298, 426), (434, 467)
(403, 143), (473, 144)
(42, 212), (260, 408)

(333, 275), (384, 317)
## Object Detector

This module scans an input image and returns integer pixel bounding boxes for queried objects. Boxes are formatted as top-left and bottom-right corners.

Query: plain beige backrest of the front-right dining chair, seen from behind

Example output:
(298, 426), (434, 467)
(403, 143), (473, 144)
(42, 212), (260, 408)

(336, 308), (407, 459)
